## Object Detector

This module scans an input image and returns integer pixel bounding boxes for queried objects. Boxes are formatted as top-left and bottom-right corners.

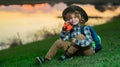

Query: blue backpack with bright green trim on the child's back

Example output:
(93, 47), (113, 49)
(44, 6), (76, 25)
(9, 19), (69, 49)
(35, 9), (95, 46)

(81, 25), (102, 52)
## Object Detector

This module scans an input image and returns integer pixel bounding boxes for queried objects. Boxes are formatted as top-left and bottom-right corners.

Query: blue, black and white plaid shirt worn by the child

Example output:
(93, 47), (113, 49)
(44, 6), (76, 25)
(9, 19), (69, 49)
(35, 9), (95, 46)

(60, 24), (93, 47)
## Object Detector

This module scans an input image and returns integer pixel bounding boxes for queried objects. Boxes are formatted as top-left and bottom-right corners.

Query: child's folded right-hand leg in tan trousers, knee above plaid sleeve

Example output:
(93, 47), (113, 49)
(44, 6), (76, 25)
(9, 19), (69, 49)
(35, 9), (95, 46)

(66, 34), (94, 57)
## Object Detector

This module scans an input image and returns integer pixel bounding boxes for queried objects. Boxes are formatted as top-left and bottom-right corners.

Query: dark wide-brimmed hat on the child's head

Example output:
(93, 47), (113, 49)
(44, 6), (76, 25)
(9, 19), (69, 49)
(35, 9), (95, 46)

(62, 5), (88, 22)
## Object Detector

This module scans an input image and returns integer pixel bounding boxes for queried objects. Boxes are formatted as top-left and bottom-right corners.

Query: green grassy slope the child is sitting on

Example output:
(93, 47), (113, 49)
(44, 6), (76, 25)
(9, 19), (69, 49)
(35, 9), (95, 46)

(0, 20), (120, 67)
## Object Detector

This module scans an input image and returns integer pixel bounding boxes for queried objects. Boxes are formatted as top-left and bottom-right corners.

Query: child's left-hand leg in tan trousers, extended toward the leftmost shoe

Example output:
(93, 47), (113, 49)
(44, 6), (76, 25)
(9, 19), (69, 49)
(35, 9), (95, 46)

(45, 39), (71, 60)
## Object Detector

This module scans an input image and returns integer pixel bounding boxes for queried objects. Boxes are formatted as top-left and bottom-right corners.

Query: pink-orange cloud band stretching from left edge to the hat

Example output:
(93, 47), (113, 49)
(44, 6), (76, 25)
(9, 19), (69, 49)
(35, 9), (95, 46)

(0, 2), (67, 13)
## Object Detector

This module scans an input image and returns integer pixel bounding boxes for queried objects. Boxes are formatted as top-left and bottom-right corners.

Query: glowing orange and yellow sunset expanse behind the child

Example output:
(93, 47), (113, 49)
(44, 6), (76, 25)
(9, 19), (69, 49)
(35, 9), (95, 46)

(0, 2), (120, 45)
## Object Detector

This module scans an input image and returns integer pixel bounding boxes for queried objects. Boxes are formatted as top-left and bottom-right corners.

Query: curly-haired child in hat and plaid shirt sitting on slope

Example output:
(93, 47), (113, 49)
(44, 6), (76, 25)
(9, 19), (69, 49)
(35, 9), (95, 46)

(36, 5), (94, 64)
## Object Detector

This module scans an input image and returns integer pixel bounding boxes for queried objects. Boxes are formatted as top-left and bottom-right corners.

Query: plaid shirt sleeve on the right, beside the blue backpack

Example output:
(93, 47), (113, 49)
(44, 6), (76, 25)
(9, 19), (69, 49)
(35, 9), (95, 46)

(75, 26), (93, 47)
